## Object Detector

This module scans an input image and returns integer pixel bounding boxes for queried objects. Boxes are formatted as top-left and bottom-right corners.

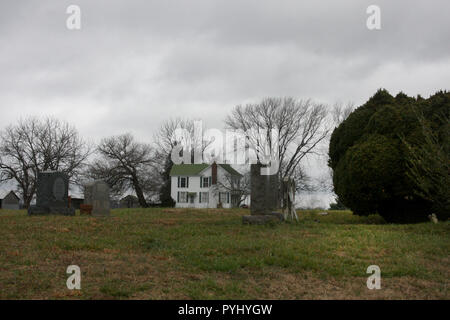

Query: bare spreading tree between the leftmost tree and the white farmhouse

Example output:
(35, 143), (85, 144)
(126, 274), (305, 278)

(88, 134), (160, 208)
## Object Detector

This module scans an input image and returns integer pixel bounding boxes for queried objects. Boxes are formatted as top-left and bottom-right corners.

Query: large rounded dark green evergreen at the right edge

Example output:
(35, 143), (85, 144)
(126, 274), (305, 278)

(329, 90), (450, 222)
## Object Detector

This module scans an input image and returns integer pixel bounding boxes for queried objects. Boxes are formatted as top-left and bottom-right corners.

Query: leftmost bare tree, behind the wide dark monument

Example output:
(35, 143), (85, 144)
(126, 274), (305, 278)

(0, 118), (91, 207)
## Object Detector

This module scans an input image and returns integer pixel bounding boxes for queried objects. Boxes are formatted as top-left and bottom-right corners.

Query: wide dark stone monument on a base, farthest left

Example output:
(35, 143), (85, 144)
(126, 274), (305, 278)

(28, 171), (75, 216)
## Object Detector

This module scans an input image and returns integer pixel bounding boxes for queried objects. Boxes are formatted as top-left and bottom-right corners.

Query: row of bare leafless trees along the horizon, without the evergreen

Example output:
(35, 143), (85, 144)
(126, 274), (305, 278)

(0, 97), (334, 207)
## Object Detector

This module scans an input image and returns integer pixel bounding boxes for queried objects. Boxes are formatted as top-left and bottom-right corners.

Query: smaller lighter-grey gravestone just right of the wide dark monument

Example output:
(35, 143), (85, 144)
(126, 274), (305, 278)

(84, 180), (110, 217)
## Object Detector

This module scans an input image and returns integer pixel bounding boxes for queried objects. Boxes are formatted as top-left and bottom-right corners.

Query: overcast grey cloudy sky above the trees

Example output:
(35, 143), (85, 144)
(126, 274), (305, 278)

(0, 0), (450, 205)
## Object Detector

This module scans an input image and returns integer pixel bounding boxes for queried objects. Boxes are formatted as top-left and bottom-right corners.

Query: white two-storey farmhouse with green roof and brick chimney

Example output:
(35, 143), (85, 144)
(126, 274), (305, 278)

(170, 162), (242, 208)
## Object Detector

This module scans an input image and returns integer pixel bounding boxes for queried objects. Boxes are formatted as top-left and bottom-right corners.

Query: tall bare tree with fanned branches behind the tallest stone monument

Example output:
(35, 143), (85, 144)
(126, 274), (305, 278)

(225, 97), (329, 179)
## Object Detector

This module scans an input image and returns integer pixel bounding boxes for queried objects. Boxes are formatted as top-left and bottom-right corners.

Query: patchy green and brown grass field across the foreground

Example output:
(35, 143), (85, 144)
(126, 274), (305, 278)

(0, 209), (450, 299)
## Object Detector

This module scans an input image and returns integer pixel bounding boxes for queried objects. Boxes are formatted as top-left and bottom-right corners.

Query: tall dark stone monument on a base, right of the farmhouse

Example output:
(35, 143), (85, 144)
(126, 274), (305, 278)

(242, 163), (283, 224)
